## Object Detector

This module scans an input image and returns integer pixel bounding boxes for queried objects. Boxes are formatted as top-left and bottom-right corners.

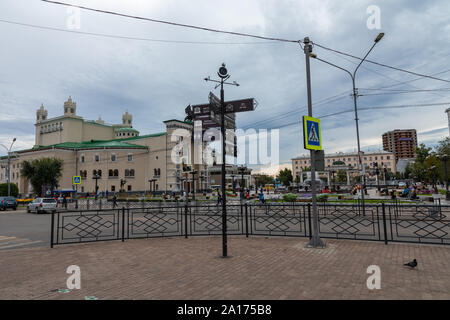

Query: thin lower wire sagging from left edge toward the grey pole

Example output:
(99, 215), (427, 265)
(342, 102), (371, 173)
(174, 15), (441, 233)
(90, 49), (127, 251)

(0, 19), (278, 45)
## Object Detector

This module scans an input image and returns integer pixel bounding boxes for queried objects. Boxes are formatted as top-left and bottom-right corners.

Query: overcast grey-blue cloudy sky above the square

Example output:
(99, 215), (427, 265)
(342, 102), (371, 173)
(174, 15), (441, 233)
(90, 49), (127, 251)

(0, 0), (450, 175)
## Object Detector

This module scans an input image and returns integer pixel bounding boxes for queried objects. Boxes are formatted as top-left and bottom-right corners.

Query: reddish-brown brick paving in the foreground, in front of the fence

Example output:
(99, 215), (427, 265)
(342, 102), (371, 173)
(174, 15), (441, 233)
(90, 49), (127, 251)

(0, 236), (450, 300)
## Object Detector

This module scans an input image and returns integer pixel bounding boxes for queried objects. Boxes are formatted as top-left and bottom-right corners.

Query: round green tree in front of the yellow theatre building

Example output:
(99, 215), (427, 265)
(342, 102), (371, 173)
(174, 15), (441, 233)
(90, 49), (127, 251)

(20, 158), (63, 196)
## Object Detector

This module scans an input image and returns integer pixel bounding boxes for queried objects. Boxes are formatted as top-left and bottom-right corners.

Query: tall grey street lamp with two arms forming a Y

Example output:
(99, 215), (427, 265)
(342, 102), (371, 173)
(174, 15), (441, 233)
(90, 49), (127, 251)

(310, 32), (384, 214)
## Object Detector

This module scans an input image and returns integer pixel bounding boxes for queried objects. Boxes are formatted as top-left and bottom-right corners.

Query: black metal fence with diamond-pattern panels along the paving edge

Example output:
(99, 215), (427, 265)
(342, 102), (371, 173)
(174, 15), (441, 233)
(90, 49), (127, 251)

(51, 203), (450, 247)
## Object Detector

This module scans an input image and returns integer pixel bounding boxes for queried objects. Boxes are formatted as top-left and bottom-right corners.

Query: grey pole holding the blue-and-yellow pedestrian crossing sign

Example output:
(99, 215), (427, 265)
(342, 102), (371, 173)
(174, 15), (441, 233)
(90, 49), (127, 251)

(304, 37), (325, 248)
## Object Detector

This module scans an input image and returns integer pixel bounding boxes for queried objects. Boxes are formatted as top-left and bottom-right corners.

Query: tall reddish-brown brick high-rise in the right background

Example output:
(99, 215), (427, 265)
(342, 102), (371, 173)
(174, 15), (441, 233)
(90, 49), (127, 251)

(382, 129), (417, 162)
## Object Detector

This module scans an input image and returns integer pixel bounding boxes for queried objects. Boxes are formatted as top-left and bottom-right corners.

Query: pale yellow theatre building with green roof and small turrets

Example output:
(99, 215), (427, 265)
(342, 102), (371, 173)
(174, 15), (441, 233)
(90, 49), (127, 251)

(0, 97), (200, 195)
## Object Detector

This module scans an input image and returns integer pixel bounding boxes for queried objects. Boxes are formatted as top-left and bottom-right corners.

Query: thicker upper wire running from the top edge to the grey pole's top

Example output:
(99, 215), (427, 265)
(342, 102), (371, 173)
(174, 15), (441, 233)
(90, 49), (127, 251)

(41, 0), (299, 43)
